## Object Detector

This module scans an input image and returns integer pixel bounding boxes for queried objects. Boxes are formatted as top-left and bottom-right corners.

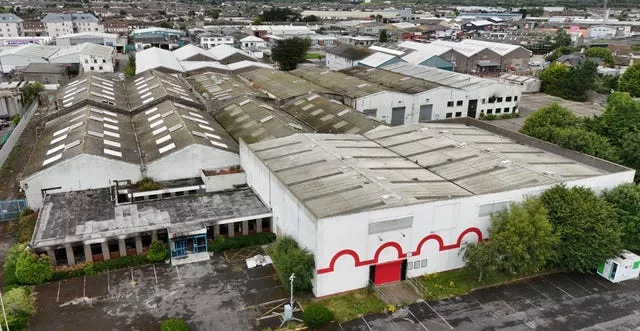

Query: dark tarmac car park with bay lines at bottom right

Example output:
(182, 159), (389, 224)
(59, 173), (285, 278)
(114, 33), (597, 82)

(333, 273), (640, 331)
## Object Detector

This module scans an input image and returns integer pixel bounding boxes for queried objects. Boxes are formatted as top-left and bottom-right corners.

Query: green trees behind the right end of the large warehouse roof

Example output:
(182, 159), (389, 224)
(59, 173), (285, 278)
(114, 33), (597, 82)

(520, 92), (640, 181)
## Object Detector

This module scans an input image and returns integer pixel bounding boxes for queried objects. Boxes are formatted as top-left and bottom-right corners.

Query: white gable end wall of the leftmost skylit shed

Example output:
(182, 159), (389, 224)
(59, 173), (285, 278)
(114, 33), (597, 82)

(20, 154), (142, 209)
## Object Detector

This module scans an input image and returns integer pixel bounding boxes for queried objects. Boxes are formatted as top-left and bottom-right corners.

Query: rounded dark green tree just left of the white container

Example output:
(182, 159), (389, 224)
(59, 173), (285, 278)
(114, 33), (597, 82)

(540, 185), (622, 272)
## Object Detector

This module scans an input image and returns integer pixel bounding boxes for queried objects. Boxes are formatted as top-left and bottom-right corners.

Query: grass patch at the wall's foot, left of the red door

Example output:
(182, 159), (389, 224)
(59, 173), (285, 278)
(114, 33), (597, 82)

(307, 289), (387, 322)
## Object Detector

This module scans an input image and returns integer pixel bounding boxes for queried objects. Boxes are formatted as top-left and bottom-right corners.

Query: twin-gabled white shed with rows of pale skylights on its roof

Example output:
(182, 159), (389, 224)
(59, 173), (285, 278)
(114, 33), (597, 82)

(21, 71), (239, 208)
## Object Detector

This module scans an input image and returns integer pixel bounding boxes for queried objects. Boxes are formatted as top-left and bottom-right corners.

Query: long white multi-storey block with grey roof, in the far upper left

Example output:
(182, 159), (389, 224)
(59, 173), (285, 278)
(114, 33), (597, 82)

(42, 13), (104, 39)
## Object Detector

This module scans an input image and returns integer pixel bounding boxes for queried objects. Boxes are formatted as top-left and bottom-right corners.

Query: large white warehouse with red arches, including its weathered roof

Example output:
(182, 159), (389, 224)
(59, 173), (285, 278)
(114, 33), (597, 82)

(240, 119), (634, 296)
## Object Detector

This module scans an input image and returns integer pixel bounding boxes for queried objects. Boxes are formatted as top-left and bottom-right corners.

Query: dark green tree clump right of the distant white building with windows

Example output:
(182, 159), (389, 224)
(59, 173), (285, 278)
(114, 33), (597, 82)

(539, 61), (598, 101)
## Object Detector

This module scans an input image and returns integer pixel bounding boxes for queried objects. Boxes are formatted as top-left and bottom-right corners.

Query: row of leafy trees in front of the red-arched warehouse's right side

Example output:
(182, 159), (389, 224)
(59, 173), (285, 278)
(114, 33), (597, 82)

(464, 184), (640, 280)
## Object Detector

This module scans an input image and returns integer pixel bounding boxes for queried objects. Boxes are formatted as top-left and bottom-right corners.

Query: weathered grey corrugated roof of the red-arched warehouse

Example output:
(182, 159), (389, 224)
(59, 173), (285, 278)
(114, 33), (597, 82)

(249, 123), (608, 218)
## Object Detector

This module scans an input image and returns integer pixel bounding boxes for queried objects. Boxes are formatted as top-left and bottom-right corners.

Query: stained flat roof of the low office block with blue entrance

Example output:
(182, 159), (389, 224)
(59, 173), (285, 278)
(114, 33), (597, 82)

(31, 188), (271, 248)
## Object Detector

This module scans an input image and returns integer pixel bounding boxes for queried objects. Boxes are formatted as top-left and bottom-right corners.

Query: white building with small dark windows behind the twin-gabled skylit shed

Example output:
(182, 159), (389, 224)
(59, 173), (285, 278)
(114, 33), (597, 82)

(49, 43), (116, 72)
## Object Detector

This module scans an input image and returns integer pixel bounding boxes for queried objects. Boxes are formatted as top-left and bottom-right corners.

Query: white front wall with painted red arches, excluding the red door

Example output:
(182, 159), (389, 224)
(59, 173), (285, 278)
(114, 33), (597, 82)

(312, 171), (633, 296)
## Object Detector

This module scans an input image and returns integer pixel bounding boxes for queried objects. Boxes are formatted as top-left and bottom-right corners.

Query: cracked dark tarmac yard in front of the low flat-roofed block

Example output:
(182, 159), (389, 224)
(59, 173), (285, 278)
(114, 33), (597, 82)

(30, 258), (287, 331)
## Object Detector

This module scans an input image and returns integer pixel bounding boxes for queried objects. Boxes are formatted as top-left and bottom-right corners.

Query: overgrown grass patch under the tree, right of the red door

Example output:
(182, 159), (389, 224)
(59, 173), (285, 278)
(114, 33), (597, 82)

(416, 268), (516, 300)
